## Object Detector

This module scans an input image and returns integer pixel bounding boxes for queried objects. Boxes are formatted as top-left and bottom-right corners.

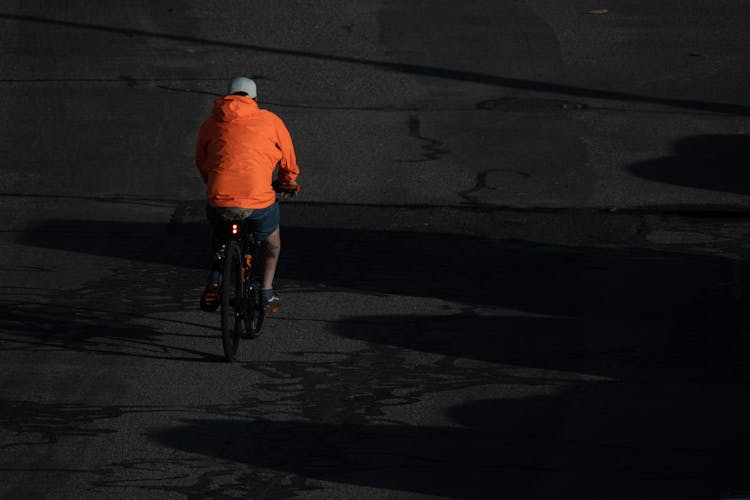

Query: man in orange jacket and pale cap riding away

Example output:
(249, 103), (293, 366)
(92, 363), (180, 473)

(195, 76), (299, 312)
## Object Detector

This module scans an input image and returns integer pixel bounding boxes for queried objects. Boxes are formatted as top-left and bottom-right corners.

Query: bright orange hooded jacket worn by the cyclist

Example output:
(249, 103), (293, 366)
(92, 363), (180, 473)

(195, 95), (299, 208)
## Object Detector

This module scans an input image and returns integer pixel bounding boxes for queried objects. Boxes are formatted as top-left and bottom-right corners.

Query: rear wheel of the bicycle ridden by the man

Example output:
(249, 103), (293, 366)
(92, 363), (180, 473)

(221, 241), (244, 363)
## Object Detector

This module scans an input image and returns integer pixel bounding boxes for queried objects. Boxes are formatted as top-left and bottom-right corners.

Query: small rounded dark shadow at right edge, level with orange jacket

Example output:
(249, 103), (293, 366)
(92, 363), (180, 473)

(628, 135), (750, 195)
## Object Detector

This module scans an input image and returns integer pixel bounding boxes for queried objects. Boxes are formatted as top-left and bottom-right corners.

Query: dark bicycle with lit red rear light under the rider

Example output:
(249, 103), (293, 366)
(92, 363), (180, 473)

(216, 183), (299, 363)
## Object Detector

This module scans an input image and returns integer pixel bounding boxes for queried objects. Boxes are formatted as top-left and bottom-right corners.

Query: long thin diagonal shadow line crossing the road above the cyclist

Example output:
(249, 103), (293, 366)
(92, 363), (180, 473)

(5, 13), (750, 116)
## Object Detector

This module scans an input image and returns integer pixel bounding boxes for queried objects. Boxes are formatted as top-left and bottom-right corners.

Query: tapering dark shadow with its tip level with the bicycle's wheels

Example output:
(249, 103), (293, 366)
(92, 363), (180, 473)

(334, 304), (750, 381)
